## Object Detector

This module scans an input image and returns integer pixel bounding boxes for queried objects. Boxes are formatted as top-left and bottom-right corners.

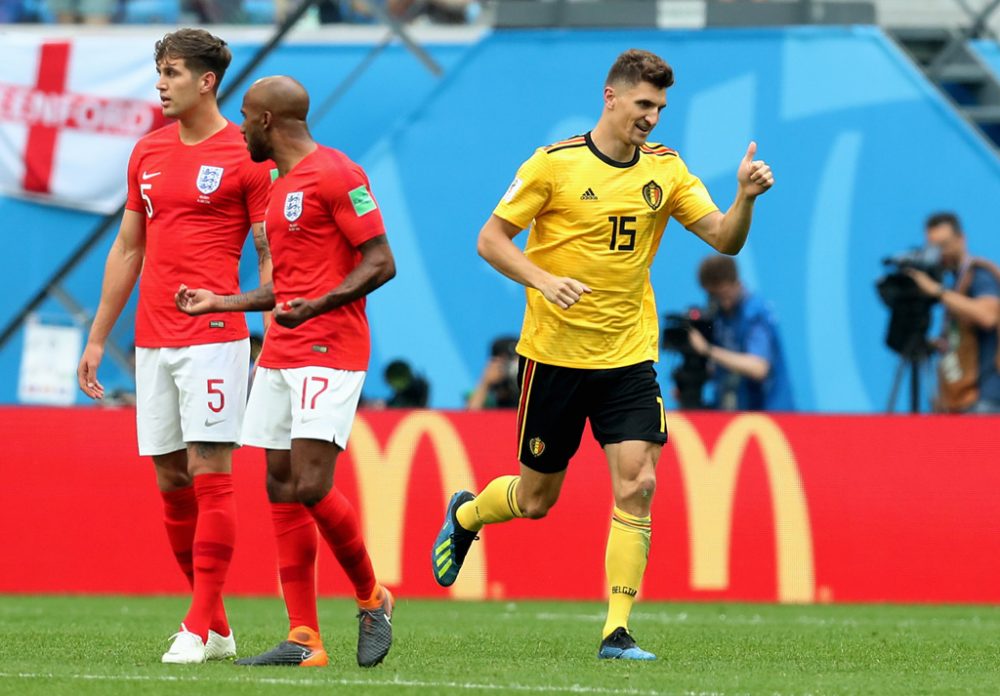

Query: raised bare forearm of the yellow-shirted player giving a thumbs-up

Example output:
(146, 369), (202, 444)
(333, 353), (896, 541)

(688, 142), (774, 255)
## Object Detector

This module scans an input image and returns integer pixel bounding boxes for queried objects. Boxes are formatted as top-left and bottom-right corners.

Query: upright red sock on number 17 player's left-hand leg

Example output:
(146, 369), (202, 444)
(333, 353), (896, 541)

(271, 503), (319, 633)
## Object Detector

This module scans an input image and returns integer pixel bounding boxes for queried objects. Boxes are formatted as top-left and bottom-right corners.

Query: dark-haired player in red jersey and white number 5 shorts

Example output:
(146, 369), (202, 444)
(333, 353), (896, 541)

(77, 29), (271, 663)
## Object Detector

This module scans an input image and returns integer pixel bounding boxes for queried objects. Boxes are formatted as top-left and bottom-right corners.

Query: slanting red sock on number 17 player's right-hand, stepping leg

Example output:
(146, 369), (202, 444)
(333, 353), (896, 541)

(309, 488), (375, 600)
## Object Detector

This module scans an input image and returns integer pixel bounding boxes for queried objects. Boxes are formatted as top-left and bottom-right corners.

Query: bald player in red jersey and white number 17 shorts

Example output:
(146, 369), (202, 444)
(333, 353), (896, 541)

(176, 77), (396, 667)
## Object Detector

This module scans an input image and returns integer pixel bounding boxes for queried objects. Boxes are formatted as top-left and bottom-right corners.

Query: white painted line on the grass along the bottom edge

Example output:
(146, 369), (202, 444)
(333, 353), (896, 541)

(0, 672), (712, 696)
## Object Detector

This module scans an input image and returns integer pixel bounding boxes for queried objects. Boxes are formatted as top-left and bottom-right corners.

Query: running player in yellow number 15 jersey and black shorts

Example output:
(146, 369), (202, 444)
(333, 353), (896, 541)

(432, 49), (774, 660)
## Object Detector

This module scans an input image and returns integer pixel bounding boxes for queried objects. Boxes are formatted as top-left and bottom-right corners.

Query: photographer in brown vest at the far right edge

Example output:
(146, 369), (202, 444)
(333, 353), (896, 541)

(906, 213), (1000, 413)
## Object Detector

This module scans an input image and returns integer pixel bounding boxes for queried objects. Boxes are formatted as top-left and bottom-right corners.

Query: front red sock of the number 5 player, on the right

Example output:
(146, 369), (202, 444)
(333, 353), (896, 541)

(184, 474), (236, 640)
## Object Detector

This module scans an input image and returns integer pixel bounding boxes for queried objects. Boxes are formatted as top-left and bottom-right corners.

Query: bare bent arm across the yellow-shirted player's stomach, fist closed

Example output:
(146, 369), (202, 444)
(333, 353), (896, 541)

(476, 215), (590, 309)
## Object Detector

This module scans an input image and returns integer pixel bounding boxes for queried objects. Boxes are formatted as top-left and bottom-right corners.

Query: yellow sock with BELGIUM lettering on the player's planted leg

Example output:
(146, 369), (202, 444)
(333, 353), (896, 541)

(601, 506), (651, 638)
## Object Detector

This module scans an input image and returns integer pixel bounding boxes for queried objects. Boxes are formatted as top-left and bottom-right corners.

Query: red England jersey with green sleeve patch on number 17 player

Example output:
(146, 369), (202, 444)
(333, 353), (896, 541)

(259, 145), (385, 371)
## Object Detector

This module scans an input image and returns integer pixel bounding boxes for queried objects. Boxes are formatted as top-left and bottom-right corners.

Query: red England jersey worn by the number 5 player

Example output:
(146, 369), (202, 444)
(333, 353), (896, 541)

(125, 123), (272, 348)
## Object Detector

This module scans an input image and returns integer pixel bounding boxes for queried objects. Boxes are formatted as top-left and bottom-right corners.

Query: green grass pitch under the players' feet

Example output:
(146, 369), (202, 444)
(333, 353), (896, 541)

(0, 596), (1000, 696)
